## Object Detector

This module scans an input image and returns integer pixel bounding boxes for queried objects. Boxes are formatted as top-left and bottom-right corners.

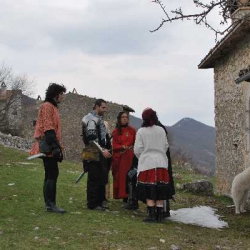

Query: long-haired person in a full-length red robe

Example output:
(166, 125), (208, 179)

(112, 111), (136, 201)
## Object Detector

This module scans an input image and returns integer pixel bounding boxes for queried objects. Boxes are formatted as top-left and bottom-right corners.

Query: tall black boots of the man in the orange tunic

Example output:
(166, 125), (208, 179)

(45, 179), (66, 214)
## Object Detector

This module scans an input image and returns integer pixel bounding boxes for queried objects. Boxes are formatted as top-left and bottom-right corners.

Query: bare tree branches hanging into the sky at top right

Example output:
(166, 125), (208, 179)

(150, 0), (250, 40)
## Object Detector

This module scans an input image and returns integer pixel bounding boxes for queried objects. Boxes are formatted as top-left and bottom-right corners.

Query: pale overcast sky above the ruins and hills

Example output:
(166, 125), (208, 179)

(0, 0), (223, 126)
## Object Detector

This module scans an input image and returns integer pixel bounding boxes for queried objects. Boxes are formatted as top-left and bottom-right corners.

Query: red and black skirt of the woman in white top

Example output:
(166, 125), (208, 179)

(136, 168), (172, 202)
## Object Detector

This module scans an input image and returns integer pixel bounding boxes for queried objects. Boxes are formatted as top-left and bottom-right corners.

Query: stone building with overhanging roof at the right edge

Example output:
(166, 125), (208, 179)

(198, 0), (250, 194)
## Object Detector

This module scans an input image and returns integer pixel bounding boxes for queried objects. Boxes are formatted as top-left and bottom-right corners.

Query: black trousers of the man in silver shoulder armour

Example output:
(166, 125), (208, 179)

(84, 161), (106, 209)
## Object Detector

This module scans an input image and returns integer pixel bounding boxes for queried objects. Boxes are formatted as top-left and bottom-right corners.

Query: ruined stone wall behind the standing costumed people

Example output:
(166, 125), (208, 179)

(22, 93), (122, 162)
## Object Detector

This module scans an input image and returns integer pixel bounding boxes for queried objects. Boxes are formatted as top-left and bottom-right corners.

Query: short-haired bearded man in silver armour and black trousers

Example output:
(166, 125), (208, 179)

(82, 99), (111, 210)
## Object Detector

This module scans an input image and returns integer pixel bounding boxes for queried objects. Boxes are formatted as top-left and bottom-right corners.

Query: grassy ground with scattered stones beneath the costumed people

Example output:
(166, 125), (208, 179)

(0, 145), (250, 250)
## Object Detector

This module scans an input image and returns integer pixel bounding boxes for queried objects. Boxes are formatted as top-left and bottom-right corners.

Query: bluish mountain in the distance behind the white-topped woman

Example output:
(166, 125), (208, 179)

(130, 116), (215, 175)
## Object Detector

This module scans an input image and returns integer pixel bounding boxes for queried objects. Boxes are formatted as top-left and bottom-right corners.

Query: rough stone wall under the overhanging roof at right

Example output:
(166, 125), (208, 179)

(214, 32), (250, 194)
